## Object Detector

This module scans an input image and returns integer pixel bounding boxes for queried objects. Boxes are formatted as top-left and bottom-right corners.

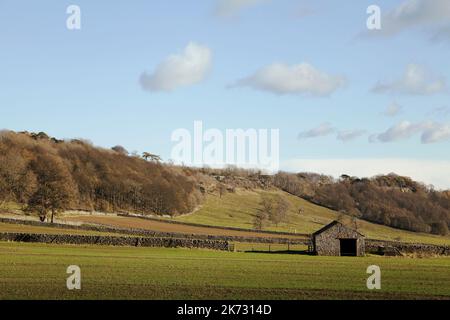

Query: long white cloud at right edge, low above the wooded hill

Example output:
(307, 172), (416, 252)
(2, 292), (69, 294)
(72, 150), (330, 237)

(369, 121), (450, 144)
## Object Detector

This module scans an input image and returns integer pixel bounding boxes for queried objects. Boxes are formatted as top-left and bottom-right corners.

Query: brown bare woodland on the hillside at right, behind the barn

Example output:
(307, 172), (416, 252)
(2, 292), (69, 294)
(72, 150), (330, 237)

(274, 173), (450, 235)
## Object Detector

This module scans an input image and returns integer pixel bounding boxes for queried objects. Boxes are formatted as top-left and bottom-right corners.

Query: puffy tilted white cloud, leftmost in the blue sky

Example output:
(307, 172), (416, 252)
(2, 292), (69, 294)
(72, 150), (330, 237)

(140, 42), (212, 91)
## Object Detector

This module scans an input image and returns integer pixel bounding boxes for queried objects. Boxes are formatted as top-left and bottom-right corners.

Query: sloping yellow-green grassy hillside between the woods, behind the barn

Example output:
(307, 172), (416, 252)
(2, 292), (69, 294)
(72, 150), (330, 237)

(175, 190), (450, 245)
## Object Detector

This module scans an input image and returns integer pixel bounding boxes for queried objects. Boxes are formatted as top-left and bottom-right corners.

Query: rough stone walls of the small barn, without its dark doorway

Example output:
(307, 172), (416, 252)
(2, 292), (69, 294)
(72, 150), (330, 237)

(313, 224), (365, 256)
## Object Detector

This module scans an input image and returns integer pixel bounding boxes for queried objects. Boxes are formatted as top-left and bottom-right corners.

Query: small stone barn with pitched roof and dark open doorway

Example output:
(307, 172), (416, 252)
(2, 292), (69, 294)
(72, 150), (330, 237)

(312, 221), (365, 257)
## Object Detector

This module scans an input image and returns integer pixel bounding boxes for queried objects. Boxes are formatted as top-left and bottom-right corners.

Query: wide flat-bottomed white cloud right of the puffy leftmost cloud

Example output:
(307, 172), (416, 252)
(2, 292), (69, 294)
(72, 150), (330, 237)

(233, 63), (345, 96)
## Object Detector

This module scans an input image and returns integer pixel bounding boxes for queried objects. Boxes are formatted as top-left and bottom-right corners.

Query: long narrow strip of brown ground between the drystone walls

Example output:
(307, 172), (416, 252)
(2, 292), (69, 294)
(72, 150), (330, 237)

(64, 216), (304, 239)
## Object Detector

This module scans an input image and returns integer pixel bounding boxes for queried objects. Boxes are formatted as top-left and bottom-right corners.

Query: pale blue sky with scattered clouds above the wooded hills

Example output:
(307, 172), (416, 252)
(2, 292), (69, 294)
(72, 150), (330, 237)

(0, 0), (450, 188)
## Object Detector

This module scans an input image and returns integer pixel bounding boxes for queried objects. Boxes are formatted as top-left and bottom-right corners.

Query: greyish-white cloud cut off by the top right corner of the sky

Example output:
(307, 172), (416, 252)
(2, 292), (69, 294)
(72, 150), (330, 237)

(374, 0), (450, 36)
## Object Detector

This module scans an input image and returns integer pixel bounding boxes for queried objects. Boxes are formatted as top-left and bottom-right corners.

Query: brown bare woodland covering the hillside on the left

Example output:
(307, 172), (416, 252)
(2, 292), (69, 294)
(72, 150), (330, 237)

(0, 132), (202, 221)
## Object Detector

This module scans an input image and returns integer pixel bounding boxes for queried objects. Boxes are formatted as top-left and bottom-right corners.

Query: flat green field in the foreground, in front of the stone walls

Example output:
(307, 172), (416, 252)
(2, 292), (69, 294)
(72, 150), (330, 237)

(0, 242), (450, 299)
